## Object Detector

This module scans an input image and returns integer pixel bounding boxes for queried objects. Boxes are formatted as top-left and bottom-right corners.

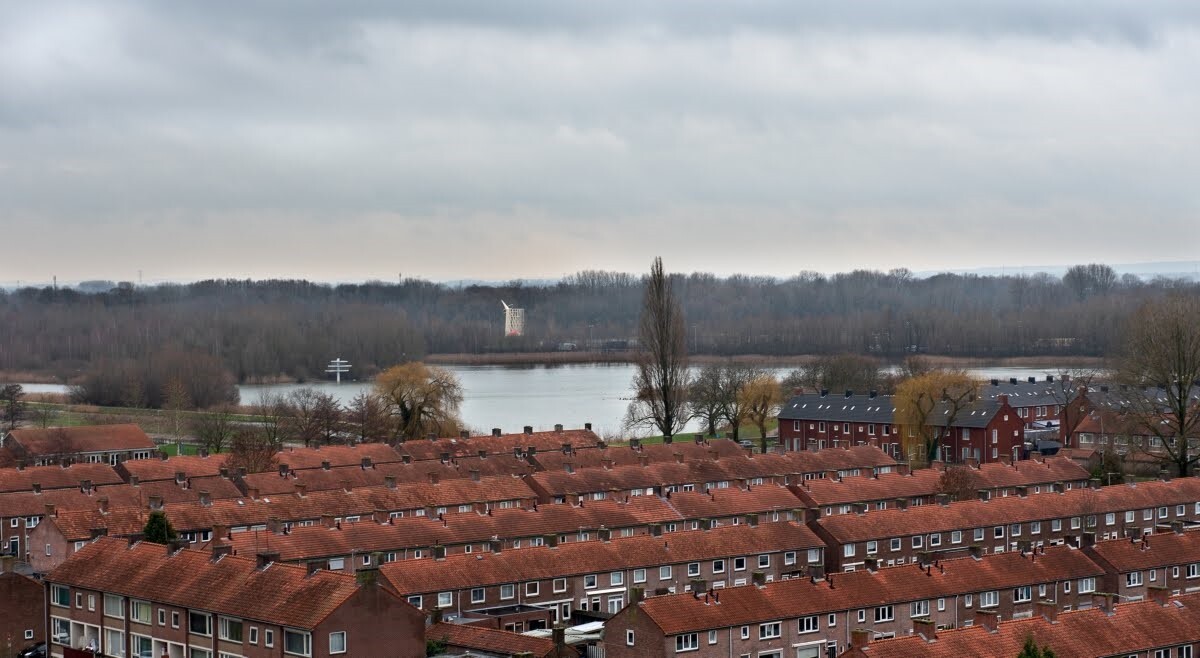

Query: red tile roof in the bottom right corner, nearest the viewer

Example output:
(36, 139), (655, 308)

(844, 594), (1200, 658)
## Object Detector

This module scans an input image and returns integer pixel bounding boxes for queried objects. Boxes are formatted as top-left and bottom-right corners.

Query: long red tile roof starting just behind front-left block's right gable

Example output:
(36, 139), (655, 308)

(382, 522), (823, 594)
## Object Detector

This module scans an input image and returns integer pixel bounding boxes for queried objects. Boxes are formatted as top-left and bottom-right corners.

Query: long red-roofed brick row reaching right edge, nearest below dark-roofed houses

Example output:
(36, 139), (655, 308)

(810, 478), (1200, 572)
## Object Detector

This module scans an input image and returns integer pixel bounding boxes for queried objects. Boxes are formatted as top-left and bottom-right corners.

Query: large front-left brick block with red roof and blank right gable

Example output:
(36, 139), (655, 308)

(46, 538), (426, 658)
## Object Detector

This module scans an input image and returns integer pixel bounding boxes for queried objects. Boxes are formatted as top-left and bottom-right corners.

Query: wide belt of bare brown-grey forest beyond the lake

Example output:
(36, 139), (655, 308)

(0, 265), (1200, 382)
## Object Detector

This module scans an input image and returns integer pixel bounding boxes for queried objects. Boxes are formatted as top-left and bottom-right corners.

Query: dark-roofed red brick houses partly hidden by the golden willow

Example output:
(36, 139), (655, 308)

(779, 390), (1025, 463)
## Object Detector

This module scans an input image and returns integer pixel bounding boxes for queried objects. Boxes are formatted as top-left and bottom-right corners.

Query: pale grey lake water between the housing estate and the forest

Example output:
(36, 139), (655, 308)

(24, 364), (1089, 435)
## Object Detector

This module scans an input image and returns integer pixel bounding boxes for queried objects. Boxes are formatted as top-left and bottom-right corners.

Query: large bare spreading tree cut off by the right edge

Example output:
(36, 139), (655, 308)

(1118, 295), (1200, 477)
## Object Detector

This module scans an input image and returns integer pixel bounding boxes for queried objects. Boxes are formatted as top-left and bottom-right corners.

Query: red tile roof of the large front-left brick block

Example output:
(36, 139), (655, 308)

(46, 538), (384, 629)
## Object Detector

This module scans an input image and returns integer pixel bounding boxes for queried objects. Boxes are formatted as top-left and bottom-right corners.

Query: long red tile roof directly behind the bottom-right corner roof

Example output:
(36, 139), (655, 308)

(624, 546), (1104, 635)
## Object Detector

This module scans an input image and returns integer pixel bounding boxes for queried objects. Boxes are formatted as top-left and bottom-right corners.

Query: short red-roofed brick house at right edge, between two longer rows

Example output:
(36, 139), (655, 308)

(1084, 524), (1200, 600)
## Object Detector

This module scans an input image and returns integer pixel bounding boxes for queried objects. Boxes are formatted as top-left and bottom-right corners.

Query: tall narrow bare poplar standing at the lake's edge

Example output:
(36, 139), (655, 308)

(625, 258), (690, 443)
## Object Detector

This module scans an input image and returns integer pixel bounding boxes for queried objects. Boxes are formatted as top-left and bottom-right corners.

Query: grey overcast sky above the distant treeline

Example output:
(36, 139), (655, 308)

(0, 0), (1200, 282)
